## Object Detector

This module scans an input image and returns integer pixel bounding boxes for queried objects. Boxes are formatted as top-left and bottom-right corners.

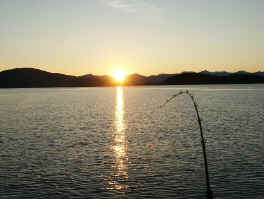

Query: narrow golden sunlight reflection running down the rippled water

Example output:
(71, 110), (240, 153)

(109, 87), (128, 191)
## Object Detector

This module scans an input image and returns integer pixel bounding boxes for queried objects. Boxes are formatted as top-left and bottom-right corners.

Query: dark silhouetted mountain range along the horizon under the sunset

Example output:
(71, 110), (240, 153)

(0, 68), (264, 88)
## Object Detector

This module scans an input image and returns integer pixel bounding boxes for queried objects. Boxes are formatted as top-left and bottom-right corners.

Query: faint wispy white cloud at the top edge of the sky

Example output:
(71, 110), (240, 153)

(101, 0), (158, 13)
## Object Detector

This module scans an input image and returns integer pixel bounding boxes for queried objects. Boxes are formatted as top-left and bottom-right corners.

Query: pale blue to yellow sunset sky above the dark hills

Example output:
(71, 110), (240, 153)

(0, 0), (264, 75)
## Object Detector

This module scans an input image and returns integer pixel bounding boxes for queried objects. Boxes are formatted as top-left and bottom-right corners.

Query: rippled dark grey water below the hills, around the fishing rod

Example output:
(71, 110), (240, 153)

(0, 84), (264, 199)
